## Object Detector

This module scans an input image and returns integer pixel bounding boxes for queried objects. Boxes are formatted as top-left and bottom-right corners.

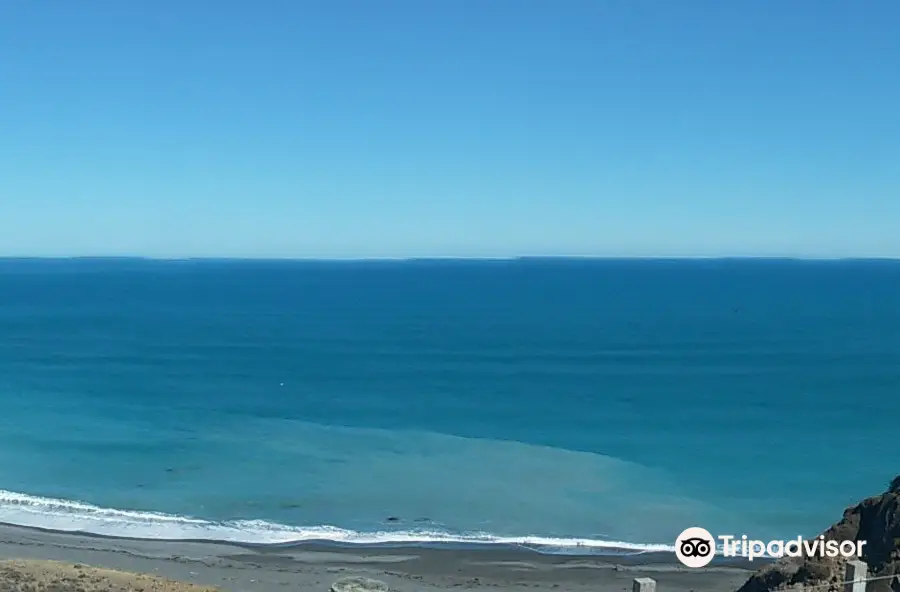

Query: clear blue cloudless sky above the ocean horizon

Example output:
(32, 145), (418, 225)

(0, 0), (900, 257)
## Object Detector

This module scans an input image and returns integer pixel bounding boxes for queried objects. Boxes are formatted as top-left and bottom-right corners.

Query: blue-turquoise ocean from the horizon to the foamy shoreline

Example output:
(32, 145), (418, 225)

(0, 259), (900, 553)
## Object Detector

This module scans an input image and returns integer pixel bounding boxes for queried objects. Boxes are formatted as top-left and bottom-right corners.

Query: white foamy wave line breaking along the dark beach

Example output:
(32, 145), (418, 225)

(0, 489), (675, 553)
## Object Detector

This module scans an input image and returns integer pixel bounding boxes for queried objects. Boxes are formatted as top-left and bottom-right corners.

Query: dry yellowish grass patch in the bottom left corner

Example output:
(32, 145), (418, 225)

(0, 560), (216, 592)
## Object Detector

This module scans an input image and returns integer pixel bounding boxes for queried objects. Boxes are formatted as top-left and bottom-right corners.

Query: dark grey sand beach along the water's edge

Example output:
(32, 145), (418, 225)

(0, 525), (759, 592)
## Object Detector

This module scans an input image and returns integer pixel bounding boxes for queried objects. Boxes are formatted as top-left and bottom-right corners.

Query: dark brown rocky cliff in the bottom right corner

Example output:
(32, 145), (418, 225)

(738, 476), (900, 592)
